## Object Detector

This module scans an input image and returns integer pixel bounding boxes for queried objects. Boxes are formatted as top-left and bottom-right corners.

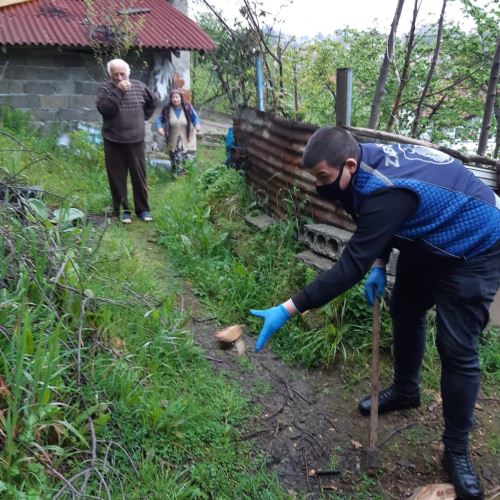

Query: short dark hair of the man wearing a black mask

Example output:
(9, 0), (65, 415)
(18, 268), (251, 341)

(302, 127), (359, 169)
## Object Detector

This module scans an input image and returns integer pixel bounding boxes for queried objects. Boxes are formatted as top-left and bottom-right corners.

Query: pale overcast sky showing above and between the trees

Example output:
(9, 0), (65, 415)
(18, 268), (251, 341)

(189, 0), (493, 37)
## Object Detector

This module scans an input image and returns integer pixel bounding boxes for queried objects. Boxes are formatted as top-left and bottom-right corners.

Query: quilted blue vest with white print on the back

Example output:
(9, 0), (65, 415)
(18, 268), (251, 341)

(353, 144), (500, 259)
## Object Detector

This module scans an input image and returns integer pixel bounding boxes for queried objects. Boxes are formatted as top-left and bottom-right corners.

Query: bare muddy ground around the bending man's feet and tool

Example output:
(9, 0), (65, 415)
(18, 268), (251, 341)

(183, 290), (500, 499)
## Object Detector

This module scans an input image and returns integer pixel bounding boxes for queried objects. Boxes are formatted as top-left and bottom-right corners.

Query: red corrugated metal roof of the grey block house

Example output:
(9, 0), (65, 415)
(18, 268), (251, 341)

(0, 0), (215, 50)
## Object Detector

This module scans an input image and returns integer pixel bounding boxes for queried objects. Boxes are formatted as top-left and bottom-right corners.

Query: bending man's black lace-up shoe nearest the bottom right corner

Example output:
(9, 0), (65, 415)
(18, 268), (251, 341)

(443, 448), (484, 500)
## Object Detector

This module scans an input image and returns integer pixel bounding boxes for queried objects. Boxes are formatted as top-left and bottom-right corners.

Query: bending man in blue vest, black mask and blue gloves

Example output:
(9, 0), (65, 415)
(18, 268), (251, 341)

(251, 127), (500, 499)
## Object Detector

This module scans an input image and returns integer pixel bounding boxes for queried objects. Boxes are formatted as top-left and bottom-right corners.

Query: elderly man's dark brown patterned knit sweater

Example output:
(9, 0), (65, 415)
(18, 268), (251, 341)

(97, 80), (160, 143)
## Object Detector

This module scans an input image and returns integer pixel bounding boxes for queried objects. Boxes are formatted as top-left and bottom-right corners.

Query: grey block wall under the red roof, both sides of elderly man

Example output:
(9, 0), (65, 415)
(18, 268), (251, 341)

(0, 47), (196, 138)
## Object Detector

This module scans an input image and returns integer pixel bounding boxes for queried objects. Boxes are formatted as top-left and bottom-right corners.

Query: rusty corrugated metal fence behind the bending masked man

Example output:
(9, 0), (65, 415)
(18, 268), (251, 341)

(234, 108), (495, 231)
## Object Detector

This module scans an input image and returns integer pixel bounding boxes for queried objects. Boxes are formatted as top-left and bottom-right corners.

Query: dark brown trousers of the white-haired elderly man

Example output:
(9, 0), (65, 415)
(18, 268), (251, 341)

(104, 140), (149, 216)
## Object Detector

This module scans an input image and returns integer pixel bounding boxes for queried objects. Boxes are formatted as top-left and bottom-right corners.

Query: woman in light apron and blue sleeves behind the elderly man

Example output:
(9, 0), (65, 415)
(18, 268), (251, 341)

(156, 89), (200, 173)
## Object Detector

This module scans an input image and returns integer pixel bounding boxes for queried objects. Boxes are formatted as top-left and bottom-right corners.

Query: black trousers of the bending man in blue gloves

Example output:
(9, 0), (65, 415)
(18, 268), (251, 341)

(391, 243), (500, 451)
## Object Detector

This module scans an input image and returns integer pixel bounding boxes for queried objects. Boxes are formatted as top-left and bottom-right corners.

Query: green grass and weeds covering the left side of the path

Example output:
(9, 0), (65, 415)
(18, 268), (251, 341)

(0, 111), (286, 499)
